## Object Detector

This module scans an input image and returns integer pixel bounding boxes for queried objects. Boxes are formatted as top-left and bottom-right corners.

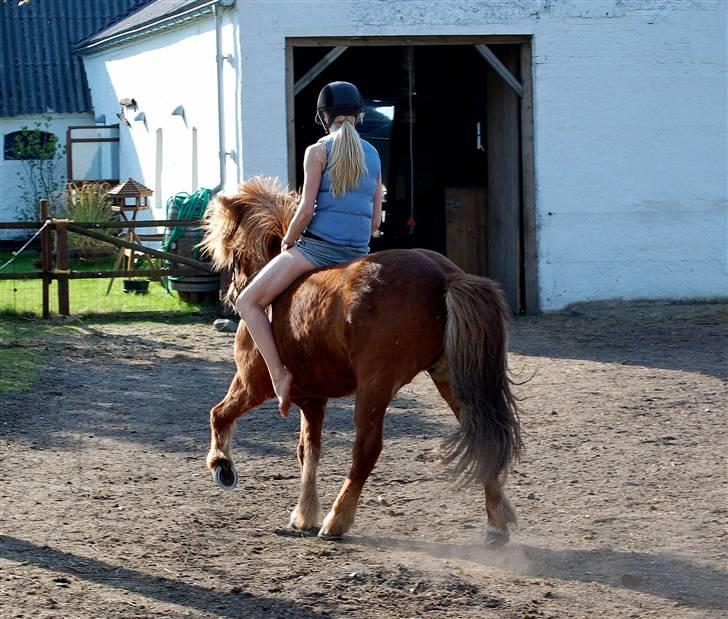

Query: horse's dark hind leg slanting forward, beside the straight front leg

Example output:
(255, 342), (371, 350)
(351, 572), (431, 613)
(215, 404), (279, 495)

(319, 389), (392, 539)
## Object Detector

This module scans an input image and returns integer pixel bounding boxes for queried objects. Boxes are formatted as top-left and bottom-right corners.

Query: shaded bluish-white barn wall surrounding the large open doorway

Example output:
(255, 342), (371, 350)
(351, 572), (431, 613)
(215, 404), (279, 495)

(237, 0), (728, 310)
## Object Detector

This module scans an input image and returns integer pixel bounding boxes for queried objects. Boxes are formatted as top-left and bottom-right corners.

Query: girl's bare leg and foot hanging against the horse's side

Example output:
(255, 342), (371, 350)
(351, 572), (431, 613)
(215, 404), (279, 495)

(235, 247), (314, 417)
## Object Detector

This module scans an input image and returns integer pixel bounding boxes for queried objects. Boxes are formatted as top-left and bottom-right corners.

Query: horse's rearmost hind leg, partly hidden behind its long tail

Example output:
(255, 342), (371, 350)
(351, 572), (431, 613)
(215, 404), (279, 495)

(428, 364), (518, 547)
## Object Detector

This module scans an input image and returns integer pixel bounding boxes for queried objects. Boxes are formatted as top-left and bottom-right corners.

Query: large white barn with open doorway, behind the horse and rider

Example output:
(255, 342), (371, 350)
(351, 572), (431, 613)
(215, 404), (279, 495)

(79, 0), (728, 311)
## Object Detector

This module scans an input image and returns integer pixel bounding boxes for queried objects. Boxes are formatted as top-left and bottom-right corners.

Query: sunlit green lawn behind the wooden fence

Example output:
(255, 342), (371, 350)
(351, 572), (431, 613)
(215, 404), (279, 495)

(0, 250), (213, 316)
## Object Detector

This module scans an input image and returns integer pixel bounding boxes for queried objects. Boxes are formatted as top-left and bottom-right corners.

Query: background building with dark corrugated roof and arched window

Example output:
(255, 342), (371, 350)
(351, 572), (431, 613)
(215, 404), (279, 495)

(0, 0), (154, 236)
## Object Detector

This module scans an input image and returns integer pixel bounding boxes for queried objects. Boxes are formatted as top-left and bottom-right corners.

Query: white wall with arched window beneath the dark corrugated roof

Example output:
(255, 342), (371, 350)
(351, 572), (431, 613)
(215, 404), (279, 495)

(0, 114), (94, 239)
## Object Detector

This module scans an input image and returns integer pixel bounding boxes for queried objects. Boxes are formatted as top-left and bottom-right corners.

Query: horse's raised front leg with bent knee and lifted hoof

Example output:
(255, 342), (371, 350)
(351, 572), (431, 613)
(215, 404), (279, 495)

(207, 327), (273, 490)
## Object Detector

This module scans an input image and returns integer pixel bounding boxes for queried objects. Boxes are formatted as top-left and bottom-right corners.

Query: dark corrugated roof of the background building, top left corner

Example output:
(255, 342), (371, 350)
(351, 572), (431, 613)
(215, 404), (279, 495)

(0, 0), (150, 117)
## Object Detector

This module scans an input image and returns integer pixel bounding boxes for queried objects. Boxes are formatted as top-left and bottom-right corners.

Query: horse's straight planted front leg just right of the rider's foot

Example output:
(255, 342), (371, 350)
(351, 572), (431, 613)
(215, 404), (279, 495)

(290, 400), (327, 531)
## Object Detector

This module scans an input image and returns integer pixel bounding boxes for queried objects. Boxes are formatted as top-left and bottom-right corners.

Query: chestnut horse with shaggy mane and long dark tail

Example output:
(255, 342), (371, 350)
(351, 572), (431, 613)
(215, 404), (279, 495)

(202, 177), (521, 545)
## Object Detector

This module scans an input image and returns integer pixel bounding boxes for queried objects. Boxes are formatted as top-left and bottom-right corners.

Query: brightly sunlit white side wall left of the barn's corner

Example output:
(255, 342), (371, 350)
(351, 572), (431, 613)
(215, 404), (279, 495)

(84, 12), (239, 219)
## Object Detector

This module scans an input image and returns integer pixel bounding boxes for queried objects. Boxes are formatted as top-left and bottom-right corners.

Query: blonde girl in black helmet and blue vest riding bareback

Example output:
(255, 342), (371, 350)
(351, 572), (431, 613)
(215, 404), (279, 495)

(235, 82), (382, 416)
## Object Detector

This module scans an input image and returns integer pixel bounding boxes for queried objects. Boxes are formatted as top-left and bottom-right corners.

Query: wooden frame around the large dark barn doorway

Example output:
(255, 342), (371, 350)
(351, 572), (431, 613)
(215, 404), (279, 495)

(285, 35), (540, 314)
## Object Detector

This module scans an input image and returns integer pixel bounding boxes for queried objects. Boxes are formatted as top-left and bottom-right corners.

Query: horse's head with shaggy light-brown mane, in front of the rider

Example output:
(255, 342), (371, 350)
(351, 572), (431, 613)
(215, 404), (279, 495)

(200, 176), (299, 303)
